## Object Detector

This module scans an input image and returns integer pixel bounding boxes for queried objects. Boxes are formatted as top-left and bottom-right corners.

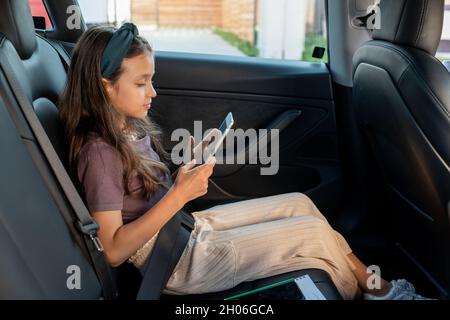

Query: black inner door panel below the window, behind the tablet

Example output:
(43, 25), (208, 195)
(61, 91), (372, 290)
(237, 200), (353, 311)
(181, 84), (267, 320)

(150, 52), (342, 218)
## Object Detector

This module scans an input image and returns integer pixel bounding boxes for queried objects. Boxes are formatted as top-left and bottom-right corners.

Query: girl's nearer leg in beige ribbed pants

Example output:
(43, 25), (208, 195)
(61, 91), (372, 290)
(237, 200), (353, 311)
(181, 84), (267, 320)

(166, 215), (358, 299)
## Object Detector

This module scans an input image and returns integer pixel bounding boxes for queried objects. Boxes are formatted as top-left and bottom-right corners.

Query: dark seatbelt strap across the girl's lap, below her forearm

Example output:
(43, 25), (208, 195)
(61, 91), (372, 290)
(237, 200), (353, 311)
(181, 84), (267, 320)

(136, 211), (191, 300)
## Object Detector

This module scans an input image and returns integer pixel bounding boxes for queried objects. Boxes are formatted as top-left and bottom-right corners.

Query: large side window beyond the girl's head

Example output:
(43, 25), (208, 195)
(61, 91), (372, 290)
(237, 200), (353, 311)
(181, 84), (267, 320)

(78, 0), (328, 62)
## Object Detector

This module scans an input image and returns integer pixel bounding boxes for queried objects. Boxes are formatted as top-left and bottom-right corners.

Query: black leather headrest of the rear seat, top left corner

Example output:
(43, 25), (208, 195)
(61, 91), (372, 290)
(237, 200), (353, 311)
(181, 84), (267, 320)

(0, 0), (36, 60)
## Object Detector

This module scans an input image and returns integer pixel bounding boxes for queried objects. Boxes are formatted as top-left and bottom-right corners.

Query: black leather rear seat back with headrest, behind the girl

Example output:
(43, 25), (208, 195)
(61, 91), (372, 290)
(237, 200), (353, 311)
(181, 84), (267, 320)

(0, 0), (107, 299)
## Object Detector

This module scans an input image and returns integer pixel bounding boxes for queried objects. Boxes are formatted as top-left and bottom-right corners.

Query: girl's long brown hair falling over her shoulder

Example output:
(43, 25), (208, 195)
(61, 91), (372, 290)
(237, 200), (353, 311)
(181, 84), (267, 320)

(58, 26), (170, 198)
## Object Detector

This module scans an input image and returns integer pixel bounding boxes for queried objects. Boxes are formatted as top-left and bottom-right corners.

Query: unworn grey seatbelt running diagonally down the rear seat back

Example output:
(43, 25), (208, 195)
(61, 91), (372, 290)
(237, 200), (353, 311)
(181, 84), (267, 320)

(0, 33), (117, 299)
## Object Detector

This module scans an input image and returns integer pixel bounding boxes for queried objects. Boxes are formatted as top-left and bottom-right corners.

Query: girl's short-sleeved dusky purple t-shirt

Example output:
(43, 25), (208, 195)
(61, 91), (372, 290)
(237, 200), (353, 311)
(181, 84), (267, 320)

(77, 133), (172, 223)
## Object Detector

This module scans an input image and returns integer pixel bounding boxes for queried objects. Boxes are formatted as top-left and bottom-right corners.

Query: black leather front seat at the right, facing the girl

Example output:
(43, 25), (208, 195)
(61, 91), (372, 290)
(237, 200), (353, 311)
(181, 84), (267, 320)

(353, 0), (450, 295)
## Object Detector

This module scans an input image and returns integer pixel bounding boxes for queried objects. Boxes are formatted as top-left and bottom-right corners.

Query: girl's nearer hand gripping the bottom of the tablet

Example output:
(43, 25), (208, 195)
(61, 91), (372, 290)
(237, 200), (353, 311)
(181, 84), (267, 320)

(174, 157), (216, 205)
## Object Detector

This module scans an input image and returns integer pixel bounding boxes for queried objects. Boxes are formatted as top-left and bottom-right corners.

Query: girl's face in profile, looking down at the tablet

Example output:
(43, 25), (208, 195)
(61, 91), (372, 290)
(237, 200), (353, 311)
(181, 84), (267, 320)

(103, 53), (156, 125)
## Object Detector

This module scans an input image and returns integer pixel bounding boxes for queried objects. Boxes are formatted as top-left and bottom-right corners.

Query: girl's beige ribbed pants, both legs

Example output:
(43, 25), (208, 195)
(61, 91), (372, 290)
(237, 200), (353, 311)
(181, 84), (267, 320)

(154, 193), (357, 299)
